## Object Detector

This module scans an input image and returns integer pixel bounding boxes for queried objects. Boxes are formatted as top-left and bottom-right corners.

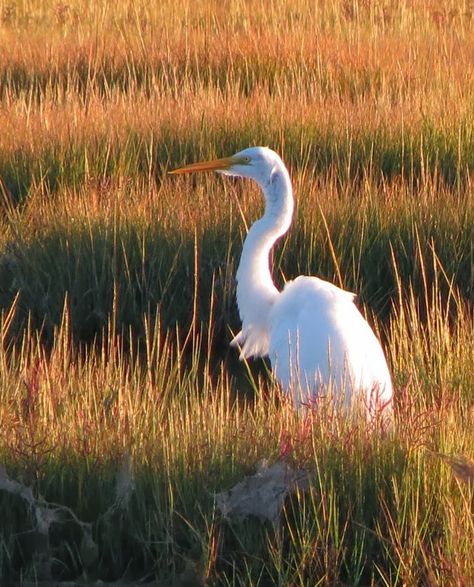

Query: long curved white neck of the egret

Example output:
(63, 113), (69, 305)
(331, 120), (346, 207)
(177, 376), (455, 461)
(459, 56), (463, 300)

(237, 164), (294, 340)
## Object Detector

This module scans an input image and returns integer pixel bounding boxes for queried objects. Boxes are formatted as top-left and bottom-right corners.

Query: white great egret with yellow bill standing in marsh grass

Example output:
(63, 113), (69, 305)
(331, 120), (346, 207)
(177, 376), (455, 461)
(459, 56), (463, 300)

(171, 147), (392, 413)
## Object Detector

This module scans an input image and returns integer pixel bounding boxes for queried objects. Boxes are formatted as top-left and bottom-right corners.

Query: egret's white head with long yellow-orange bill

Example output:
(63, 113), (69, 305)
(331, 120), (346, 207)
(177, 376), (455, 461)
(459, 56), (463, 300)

(170, 147), (284, 185)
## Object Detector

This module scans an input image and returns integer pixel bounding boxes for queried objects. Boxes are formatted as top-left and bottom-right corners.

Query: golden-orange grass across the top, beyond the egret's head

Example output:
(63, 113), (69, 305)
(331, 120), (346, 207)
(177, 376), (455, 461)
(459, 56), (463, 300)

(0, 2), (474, 152)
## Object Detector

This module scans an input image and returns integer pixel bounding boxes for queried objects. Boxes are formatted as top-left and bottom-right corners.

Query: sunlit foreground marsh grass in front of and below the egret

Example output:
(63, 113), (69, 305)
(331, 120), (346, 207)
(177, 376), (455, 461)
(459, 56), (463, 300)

(0, 286), (474, 585)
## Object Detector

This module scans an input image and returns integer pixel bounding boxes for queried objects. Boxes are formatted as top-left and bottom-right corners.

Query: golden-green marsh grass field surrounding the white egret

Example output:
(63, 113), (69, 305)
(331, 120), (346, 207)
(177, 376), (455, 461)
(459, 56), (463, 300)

(0, 0), (474, 587)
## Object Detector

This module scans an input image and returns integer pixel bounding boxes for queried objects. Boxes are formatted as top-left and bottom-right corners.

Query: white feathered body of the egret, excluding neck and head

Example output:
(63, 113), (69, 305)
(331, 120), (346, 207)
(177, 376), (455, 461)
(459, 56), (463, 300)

(269, 276), (392, 412)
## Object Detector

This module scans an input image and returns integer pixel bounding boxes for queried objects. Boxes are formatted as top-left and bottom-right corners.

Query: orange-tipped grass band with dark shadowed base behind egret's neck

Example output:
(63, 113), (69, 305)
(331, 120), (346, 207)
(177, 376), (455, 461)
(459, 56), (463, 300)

(0, 175), (474, 346)
